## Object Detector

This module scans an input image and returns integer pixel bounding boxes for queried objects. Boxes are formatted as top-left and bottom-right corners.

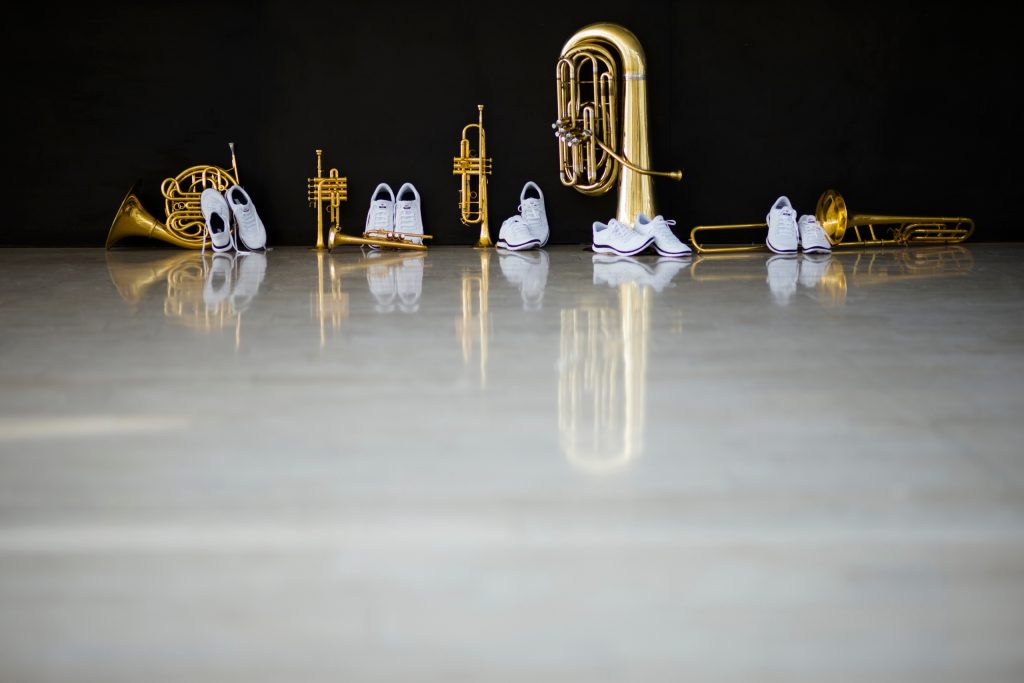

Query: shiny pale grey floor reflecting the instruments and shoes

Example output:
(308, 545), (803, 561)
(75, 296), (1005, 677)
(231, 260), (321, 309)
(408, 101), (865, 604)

(0, 244), (1024, 683)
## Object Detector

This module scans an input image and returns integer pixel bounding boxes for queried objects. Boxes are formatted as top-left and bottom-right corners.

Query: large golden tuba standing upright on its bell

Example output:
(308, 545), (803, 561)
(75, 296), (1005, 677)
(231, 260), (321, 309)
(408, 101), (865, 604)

(552, 24), (683, 225)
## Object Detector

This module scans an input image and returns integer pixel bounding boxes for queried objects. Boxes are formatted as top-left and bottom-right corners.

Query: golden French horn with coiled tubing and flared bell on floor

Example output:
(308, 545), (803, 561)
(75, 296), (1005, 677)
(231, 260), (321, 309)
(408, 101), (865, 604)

(105, 142), (239, 249)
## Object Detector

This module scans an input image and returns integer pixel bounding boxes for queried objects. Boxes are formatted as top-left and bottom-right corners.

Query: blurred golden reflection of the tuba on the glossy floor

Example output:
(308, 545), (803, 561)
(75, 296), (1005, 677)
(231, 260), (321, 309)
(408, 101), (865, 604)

(558, 282), (653, 474)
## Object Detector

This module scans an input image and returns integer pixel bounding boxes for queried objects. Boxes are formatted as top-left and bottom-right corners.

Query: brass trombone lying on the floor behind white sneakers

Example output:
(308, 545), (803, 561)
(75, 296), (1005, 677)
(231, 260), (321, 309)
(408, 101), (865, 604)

(690, 189), (974, 254)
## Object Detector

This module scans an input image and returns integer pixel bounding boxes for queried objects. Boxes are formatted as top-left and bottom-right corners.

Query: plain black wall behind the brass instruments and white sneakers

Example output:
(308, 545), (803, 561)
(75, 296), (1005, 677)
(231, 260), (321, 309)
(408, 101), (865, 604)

(0, 0), (1021, 246)
